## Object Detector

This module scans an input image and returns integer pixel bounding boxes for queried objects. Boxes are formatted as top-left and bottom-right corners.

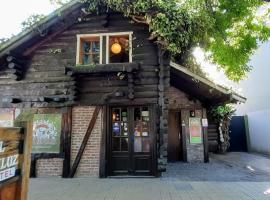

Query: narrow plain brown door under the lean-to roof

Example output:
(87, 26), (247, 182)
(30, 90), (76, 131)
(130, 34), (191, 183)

(168, 111), (182, 162)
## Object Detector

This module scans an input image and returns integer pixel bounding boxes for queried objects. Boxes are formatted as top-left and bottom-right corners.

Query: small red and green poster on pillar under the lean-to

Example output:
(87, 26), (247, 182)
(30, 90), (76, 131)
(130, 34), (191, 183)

(189, 117), (203, 144)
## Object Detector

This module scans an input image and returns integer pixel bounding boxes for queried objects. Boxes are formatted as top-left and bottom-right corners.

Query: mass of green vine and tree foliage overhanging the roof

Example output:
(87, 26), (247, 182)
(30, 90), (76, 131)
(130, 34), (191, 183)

(19, 0), (270, 81)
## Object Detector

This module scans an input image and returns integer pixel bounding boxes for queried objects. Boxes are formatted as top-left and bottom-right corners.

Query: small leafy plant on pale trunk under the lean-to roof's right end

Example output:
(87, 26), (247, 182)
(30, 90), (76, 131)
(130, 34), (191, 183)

(211, 105), (235, 153)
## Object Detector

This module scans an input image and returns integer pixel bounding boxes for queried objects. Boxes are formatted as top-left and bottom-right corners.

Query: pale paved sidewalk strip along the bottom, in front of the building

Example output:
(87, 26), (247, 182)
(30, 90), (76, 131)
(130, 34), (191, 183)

(29, 178), (270, 200)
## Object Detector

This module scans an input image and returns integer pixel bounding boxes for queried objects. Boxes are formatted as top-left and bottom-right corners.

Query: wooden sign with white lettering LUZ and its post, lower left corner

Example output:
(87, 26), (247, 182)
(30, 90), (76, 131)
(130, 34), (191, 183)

(0, 124), (32, 200)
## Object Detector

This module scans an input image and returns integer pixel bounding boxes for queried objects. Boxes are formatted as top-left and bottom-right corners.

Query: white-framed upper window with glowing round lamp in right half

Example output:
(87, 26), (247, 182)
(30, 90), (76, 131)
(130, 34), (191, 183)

(76, 32), (132, 65)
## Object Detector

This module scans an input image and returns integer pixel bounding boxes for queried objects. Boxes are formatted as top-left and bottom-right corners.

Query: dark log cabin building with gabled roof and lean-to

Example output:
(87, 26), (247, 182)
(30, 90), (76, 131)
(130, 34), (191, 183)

(0, 1), (245, 177)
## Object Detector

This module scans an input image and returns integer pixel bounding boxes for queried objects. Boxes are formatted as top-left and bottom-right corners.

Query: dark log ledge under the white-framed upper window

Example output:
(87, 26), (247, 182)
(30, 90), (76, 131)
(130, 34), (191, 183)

(66, 63), (140, 75)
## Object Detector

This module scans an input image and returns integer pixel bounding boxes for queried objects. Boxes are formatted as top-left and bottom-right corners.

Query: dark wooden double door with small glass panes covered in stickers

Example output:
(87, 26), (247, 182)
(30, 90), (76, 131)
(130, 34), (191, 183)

(109, 106), (154, 176)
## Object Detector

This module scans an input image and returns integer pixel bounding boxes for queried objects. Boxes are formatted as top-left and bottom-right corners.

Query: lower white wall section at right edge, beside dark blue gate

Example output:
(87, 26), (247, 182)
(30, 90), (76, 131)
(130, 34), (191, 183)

(248, 109), (270, 155)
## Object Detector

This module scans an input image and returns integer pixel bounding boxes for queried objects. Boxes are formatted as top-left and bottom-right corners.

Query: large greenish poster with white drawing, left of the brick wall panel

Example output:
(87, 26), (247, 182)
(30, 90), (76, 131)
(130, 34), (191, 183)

(32, 114), (62, 153)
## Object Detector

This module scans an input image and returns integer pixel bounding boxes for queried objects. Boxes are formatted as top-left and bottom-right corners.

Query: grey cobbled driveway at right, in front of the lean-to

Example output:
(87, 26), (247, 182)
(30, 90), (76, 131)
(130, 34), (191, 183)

(163, 152), (270, 182)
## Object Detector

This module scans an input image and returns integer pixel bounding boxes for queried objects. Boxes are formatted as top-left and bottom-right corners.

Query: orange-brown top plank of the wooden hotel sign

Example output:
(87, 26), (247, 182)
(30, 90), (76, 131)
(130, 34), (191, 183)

(0, 128), (23, 141)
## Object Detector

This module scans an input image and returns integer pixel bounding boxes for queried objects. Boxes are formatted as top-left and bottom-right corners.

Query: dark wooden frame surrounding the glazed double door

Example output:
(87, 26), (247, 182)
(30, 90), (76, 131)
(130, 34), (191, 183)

(102, 104), (158, 178)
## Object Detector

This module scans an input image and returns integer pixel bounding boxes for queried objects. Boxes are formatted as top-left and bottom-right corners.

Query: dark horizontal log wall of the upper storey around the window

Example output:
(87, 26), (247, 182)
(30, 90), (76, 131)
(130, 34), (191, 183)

(0, 14), (159, 108)
